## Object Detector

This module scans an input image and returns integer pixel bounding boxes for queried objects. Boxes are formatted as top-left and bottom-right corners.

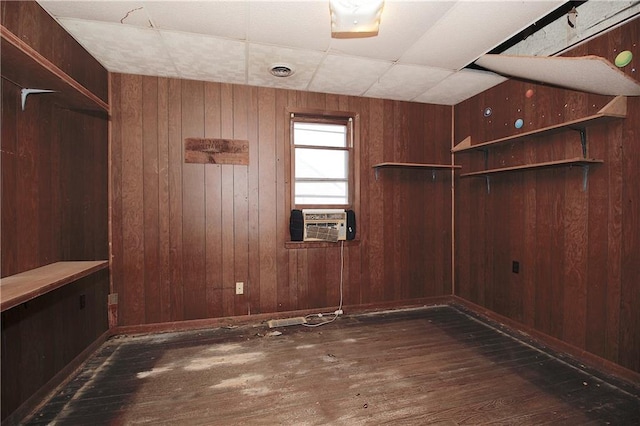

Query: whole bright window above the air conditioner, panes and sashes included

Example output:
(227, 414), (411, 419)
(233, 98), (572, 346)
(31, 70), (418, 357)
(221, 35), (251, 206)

(291, 114), (354, 208)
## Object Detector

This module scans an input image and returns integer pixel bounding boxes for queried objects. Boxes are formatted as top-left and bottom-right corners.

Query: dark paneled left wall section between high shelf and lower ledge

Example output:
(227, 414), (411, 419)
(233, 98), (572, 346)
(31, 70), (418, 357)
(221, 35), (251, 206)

(0, 79), (109, 277)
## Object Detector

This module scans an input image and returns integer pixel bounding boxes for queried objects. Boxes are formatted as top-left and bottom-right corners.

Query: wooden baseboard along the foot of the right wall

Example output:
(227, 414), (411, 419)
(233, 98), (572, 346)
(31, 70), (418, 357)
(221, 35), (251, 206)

(451, 296), (640, 389)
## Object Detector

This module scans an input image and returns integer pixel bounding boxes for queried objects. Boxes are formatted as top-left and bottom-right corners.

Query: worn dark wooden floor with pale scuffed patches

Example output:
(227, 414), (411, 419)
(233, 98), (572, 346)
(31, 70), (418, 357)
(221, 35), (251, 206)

(26, 307), (640, 425)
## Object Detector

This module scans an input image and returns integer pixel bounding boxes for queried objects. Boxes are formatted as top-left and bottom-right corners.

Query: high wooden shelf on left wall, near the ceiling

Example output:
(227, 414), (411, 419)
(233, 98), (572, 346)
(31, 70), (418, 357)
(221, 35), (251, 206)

(0, 25), (109, 114)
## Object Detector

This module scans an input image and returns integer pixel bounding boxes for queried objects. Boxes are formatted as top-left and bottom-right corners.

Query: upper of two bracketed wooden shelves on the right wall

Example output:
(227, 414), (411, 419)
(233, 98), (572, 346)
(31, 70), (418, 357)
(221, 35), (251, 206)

(451, 96), (627, 153)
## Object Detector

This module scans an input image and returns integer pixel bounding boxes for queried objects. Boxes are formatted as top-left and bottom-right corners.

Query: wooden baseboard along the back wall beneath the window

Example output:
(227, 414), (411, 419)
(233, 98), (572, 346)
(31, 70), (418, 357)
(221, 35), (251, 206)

(111, 296), (452, 336)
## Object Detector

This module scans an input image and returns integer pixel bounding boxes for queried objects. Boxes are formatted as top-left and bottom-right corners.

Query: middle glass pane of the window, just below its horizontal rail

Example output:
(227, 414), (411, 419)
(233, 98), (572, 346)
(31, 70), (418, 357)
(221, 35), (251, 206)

(295, 148), (349, 179)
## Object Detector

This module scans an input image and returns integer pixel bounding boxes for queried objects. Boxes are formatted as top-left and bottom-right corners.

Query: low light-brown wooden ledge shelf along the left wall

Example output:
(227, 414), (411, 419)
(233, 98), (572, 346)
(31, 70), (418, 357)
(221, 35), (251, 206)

(0, 260), (109, 312)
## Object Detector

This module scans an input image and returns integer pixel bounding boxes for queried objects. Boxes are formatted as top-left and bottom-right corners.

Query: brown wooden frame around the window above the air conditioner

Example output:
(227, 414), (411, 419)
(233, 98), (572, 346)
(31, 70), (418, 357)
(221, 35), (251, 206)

(286, 109), (360, 212)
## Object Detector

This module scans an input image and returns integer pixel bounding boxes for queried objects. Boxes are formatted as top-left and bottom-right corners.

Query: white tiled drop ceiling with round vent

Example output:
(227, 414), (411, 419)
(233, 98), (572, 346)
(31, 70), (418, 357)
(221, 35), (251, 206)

(38, 0), (636, 105)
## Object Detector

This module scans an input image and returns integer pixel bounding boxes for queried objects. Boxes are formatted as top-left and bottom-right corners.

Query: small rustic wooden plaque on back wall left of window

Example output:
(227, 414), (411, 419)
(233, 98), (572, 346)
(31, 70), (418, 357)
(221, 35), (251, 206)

(184, 138), (249, 165)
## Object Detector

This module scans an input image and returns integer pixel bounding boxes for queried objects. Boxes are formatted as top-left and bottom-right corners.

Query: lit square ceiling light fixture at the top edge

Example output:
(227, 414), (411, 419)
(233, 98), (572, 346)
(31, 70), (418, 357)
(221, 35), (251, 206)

(329, 0), (384, 38)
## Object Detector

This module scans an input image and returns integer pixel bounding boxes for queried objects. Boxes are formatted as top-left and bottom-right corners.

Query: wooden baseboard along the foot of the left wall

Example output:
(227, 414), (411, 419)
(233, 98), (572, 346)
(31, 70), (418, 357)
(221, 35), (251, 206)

(2, 330), (112, 426)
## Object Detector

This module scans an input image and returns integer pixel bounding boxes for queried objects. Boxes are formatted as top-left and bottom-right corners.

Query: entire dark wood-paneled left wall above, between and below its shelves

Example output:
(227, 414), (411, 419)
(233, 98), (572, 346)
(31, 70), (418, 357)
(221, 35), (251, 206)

(0, 1), (109, 421)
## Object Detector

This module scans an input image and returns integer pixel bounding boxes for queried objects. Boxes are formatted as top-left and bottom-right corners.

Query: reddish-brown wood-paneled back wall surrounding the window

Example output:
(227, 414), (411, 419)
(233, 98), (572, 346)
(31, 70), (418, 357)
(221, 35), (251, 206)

(111, 74), (452, 325)
